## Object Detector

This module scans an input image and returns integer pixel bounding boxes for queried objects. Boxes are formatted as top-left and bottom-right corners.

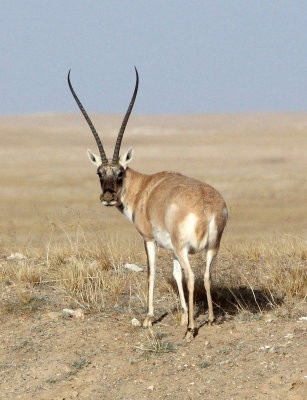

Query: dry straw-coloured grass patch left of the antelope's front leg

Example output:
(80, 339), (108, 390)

(0, 225), (143, 310)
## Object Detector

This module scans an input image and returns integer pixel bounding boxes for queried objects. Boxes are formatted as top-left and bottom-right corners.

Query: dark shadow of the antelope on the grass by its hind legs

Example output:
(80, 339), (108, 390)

(168, 277), (282, 336)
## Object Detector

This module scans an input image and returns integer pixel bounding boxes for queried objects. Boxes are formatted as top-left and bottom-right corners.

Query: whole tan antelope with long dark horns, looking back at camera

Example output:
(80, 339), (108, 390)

(67, 68), (228, 342)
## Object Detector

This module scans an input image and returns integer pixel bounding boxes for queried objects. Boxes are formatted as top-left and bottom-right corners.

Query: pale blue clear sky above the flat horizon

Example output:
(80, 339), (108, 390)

(0, 0), (307, 115)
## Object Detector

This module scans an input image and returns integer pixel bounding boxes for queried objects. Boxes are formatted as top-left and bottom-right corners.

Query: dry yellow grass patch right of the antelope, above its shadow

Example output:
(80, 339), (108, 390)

(221, 235), (307, 299)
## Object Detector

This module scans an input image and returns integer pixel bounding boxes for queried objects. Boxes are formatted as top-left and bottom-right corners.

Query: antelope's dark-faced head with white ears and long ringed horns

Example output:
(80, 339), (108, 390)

(67, 67), (139, 206)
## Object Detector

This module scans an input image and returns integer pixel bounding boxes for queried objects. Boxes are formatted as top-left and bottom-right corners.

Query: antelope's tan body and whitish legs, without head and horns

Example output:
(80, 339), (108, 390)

(119, 168), (227, 340)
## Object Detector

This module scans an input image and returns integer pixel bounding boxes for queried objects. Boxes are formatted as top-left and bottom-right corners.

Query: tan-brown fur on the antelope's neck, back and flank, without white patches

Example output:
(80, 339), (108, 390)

(123, 168), (227, 252)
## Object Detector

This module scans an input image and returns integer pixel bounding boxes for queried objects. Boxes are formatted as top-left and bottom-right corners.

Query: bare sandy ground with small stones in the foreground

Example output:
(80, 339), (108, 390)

(0, 292), (306, 400)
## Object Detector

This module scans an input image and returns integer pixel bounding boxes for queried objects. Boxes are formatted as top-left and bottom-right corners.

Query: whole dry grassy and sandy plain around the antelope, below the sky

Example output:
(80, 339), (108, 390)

(0, 113), (307, 400)
